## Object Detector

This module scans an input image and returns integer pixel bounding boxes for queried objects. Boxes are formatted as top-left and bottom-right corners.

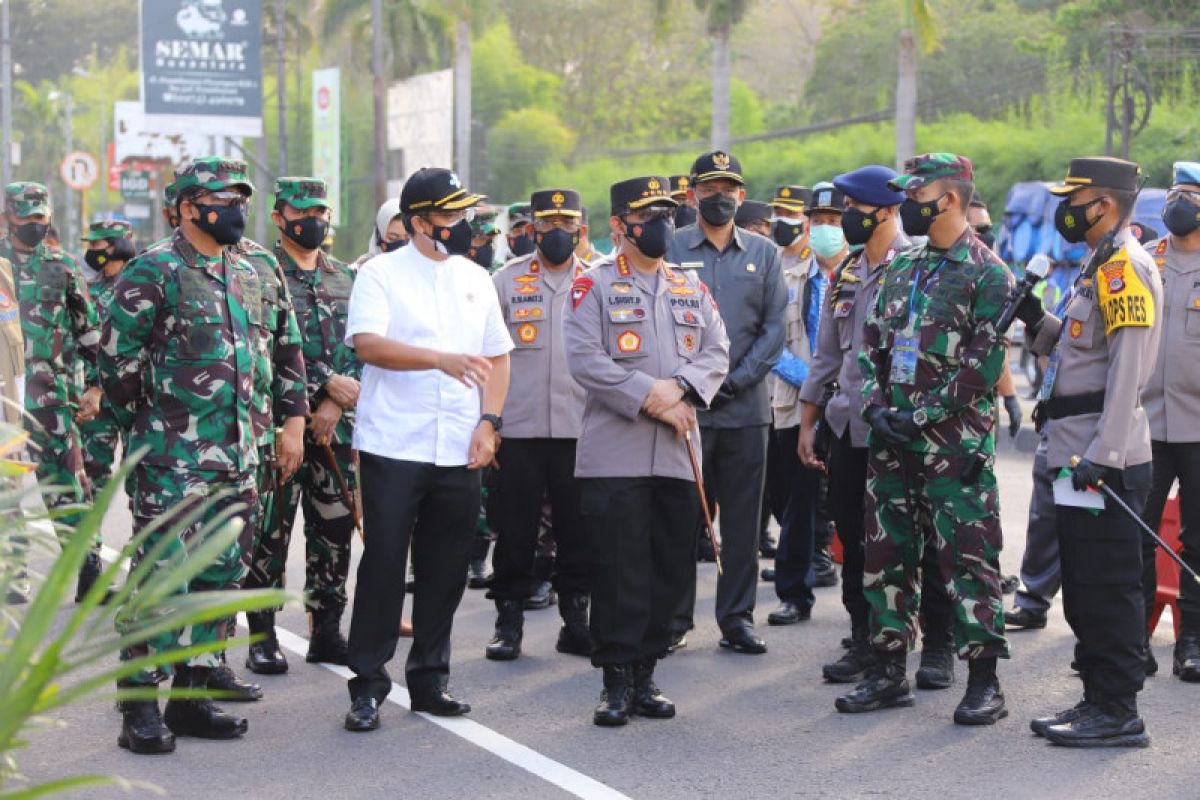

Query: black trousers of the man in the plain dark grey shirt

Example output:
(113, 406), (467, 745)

(673, 425), (767, 633)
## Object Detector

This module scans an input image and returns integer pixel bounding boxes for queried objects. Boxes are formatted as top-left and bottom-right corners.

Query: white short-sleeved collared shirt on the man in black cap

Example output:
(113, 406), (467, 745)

(346, 245), (512, 467)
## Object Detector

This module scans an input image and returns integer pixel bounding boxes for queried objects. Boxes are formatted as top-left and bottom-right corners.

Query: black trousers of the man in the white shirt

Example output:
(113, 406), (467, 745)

(349, 452), (480, 703)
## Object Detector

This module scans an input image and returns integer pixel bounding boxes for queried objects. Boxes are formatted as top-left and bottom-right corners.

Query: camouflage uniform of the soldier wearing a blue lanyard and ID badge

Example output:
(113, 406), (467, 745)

(859, 220), (1012, 657)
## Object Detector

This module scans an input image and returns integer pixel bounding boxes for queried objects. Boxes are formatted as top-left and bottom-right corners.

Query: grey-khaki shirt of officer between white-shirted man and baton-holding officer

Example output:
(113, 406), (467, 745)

(492, 253), (584, 439)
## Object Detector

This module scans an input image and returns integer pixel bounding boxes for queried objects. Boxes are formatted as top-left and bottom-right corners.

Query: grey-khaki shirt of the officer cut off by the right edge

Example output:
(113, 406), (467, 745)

(1141, 236), (1200, 441)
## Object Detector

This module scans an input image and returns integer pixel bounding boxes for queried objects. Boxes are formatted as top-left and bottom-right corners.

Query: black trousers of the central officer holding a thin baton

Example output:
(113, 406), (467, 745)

(580, 477), (700, 667)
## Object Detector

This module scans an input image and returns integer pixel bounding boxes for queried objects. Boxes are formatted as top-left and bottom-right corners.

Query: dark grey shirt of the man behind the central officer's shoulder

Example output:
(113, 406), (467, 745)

(666, 224), (787, 428)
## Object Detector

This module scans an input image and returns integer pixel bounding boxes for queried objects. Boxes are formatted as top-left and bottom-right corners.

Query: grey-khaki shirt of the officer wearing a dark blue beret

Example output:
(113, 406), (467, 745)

(799, 234), (908, 447)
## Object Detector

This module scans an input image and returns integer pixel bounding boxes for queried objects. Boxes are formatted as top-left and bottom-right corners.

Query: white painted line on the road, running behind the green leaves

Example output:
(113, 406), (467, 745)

(101, 545), (630, 800)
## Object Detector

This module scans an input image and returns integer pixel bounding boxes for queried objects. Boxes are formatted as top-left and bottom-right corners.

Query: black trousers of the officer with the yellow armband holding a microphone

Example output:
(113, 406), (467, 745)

(1057, 464), (1152, 696)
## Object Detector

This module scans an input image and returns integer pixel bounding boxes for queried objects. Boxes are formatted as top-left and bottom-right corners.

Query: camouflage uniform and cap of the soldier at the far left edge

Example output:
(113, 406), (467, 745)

(0, 184), (100, 547)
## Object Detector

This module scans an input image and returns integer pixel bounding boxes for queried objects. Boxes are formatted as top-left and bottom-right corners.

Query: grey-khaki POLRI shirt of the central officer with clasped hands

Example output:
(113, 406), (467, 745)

(563, 255), (730, 481)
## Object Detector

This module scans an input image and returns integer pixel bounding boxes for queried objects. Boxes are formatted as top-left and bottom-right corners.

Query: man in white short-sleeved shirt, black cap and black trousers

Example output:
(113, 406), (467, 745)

(346, 168), (512, 730)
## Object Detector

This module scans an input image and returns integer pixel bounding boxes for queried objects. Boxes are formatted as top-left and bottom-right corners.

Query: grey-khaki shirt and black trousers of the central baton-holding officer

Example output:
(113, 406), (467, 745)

(563, 250), (730, 667)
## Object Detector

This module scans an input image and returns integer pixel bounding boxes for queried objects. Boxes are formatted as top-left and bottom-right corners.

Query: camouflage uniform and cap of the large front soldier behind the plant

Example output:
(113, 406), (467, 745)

(100, 158), (304, 682)
